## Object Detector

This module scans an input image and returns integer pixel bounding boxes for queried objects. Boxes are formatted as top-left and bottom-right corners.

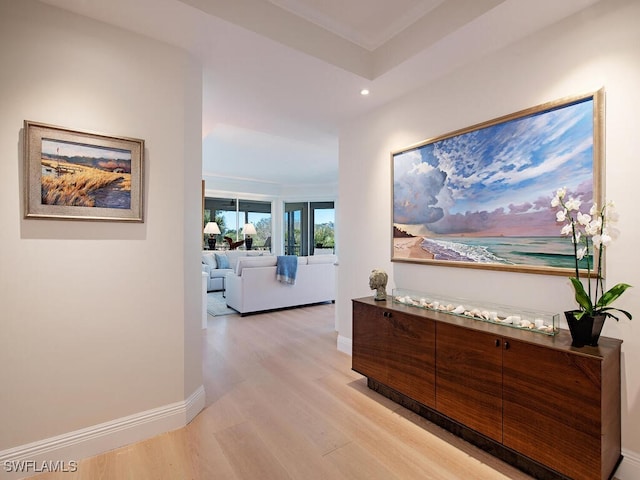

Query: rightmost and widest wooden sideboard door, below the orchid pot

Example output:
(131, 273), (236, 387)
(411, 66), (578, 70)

(503, 341), (617, 480)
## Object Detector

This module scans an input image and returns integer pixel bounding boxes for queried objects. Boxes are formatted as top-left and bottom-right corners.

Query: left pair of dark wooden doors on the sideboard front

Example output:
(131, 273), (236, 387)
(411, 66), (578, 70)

(352, 302), (435, 407)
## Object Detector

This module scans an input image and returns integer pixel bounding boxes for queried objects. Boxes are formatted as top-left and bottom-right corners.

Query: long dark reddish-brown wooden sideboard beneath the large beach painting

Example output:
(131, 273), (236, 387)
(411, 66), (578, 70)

(352, 298), (622, 480)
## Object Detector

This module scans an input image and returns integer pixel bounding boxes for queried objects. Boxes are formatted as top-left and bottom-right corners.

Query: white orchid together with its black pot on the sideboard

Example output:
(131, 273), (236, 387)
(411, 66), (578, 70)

(551, 188), (632, 347)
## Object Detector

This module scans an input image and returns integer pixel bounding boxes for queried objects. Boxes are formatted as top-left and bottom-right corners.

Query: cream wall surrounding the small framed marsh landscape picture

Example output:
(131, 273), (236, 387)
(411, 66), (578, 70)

(0, 0), (203, 459)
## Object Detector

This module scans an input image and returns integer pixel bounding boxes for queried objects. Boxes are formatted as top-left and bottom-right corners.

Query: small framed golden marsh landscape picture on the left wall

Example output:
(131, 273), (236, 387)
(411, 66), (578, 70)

(24, 121), (144, 222)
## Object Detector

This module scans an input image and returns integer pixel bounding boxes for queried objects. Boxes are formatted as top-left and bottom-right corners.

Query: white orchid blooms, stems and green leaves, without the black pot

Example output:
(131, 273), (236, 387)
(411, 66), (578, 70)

(551, 188), (632, 320)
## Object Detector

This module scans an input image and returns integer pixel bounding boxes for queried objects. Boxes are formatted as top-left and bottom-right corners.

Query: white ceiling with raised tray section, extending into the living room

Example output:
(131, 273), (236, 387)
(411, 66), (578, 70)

(41, 0), (599, 185)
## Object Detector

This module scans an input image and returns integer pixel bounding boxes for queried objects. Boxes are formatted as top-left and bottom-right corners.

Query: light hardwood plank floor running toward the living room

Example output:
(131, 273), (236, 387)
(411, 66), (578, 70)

(32, 304), (530, 480)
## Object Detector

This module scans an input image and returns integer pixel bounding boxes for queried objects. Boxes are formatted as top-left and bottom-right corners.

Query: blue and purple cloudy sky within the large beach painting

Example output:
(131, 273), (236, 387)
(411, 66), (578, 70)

(394, 100), (593, 236)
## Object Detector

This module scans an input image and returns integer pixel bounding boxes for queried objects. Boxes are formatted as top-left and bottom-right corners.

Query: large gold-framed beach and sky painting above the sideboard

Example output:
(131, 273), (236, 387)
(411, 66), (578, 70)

(391, 90), (604, 275)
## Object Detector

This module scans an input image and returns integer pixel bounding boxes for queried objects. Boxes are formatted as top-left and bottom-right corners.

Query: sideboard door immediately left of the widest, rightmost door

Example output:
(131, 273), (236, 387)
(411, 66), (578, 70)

(436, 323), (503, 442)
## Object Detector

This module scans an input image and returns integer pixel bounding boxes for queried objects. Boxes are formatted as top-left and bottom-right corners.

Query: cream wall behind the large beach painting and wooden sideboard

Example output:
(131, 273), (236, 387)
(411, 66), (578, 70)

(337, 0), (640, 472)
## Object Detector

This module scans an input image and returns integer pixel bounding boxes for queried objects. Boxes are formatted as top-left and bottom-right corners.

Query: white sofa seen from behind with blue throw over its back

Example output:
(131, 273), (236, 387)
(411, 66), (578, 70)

(225, 255), (336, 315)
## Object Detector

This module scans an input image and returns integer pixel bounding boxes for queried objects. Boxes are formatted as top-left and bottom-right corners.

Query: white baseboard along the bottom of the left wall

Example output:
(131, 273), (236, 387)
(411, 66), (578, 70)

(0, 385), (205, 479)
